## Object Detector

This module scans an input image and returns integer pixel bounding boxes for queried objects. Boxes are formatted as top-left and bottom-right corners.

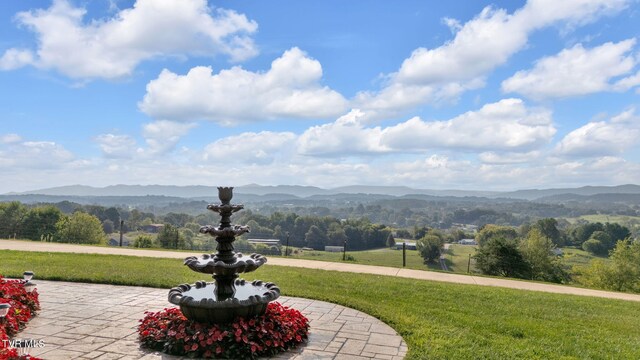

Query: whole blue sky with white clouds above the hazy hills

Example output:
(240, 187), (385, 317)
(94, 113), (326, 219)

(0, 0), (640, 193)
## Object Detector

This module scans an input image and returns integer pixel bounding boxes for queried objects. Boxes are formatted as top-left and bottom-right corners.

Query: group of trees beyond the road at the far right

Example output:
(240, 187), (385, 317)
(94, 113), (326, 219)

(462, 218), (640, 292)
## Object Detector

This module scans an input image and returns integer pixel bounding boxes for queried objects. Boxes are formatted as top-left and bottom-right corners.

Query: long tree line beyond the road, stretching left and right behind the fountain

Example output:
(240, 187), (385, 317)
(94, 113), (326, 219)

(0, 201), (393, 250)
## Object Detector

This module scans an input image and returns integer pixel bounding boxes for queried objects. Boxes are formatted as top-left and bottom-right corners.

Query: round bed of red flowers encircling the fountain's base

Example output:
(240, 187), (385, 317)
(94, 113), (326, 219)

(138, 302), (309, 359)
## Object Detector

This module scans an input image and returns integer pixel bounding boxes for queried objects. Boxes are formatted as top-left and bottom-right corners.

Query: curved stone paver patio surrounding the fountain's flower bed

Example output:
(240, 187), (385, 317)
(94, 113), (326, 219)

(16, 281), (407, 360)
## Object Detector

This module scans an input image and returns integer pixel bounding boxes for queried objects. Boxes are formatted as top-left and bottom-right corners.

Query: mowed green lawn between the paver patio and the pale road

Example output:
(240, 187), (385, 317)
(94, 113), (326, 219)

(0, 251), (640, 359)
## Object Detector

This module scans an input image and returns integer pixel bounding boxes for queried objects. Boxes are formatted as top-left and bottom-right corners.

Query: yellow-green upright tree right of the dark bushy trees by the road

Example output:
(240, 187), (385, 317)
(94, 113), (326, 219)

(520, 227), (568, 283)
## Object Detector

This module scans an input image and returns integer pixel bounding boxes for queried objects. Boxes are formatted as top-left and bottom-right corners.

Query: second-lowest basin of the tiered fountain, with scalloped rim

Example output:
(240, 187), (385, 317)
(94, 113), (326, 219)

(184, 253), (267, 275)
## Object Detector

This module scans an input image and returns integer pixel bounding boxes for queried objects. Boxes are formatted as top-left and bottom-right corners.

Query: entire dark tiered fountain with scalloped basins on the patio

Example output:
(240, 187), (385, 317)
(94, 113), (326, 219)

(169, 187), (280, 324)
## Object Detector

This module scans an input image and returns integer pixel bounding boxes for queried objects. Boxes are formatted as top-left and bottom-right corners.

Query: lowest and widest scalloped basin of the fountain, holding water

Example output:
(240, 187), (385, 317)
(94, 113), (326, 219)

(169, 279), (280, 324)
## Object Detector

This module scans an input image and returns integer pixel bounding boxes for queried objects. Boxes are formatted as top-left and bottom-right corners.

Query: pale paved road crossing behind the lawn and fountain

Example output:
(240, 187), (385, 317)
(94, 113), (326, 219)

(0, 240), (640, 302)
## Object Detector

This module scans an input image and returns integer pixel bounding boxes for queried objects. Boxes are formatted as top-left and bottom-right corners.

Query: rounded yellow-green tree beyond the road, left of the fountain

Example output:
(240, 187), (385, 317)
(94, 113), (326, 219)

(55, 211), (107, 244)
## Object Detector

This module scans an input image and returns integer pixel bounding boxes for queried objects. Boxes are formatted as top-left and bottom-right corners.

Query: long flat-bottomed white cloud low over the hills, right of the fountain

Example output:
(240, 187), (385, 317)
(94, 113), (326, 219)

(298, 99), (556, 156)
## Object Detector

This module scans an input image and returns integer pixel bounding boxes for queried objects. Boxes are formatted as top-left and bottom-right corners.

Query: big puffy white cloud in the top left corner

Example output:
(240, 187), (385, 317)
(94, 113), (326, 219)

(0, 0), (257, 79)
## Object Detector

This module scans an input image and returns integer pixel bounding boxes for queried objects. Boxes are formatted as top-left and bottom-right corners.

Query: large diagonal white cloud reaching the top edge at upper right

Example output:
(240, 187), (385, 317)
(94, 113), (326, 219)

(355, 0), (628, 119)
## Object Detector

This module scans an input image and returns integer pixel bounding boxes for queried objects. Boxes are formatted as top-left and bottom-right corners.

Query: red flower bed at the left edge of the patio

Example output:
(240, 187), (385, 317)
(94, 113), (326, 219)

(0, 275), (40, 360)
